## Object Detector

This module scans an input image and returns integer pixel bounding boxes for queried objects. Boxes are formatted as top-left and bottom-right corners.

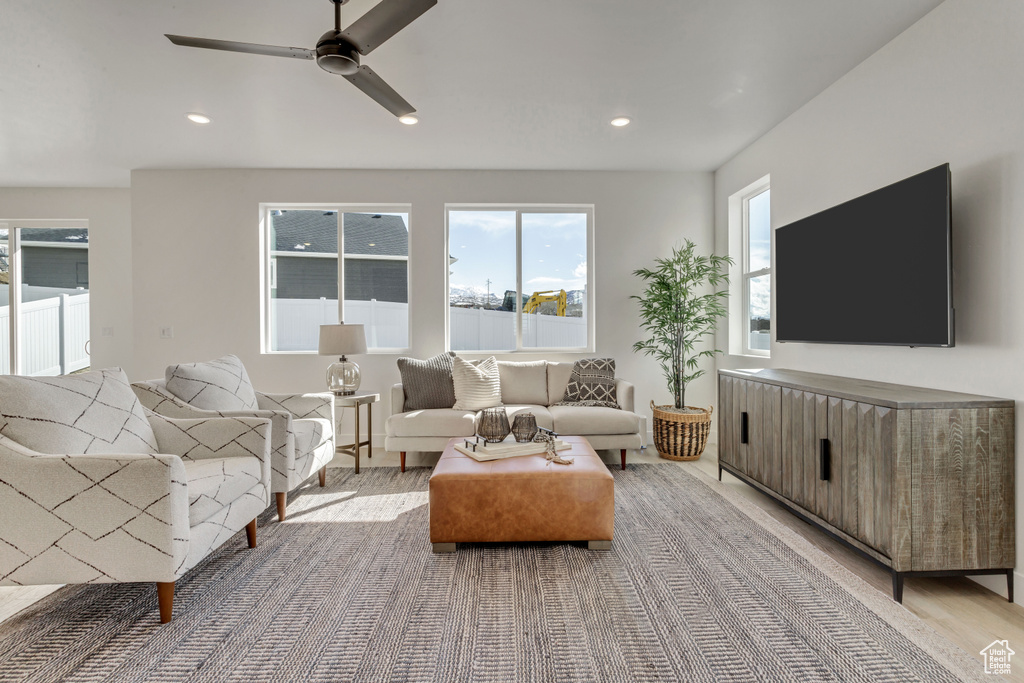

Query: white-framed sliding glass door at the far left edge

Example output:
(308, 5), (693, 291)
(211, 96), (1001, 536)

(0, 220), (89, 376)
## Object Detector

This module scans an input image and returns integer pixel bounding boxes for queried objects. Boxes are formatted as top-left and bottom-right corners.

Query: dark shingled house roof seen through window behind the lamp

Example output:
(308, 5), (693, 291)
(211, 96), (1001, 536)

(270, 210), (409, 256)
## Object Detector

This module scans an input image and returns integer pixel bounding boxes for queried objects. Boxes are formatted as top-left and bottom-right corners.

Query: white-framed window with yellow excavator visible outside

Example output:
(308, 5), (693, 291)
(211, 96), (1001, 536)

(447, 206), (594, 351)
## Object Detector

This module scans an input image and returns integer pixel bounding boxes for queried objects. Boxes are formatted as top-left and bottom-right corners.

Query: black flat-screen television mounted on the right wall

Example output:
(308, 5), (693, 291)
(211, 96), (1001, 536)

(775, 164), (954, 346)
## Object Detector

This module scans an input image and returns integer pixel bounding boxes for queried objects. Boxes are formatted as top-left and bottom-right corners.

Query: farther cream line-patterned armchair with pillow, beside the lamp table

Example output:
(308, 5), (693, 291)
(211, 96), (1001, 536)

(132, 355), (335, 521)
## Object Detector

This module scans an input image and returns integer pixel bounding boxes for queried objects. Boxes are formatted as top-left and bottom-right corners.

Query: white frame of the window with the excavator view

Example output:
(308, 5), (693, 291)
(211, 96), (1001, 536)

(443, 204), (597, 355)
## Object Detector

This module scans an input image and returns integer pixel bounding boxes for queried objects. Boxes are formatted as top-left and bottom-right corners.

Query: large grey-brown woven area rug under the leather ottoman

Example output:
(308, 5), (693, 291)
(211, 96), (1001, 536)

(0, 464), (991, 683)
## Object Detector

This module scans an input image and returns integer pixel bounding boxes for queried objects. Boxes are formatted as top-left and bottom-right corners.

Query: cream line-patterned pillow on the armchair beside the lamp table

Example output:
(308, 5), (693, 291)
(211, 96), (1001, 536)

(165, 355), (258, 411)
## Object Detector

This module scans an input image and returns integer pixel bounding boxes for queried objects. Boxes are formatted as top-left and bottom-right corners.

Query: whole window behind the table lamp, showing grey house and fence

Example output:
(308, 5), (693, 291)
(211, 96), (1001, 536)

(262, 205), (409, 352)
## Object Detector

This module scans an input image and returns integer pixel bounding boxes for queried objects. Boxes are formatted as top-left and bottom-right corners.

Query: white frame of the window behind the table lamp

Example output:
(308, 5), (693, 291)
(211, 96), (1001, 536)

(259, 202), (413, 355)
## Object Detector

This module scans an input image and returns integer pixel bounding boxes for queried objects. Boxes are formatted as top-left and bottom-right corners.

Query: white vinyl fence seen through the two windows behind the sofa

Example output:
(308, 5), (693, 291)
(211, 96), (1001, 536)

(270, 299), (587, 351)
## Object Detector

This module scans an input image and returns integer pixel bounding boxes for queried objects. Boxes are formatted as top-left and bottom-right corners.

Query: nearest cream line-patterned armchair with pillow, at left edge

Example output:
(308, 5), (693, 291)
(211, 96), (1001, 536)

(0, 368), (270, 624)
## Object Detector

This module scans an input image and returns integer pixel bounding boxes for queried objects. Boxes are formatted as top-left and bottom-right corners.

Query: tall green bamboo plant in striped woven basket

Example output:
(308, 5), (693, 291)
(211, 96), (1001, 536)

(631, 240), (732, 460)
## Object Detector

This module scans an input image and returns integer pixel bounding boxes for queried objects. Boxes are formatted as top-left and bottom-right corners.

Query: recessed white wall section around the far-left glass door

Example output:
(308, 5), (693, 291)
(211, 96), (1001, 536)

(0, 187), (133, 377)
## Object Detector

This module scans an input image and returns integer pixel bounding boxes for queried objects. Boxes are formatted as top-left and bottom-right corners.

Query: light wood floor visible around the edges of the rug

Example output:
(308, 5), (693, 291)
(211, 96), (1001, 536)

(0, 446), (1024, 682)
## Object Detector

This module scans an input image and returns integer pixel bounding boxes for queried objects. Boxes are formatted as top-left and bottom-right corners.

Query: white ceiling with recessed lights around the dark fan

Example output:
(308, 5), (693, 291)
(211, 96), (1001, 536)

(0, 0), (940, 186)
